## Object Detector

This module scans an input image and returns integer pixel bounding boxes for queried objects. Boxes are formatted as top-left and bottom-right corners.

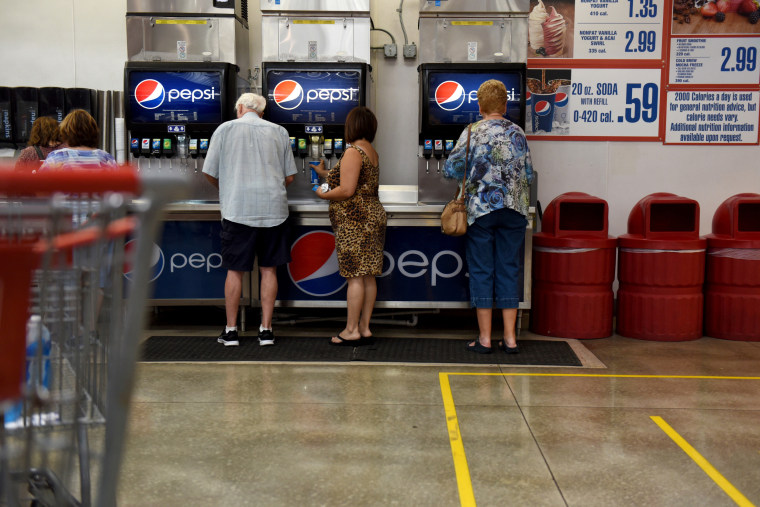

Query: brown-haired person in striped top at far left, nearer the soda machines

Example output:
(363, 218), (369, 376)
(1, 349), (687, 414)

(40, 109), (118, 171)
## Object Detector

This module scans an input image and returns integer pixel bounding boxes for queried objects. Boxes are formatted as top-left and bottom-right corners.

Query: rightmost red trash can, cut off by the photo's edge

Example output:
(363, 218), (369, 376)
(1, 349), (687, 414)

(705, 194), (760, 341)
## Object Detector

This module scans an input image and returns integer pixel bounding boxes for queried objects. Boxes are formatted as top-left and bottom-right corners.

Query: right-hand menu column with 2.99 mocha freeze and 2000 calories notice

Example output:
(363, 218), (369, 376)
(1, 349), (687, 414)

(664, 0), (760, 145)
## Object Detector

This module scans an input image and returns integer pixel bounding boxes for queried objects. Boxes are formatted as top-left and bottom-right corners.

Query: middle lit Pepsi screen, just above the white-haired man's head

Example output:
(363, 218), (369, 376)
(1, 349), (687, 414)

(266, 70), (362, 125)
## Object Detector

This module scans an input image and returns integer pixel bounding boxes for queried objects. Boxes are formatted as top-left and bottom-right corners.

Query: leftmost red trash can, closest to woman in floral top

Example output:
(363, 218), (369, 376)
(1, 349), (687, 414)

(530, 192), (617, 338)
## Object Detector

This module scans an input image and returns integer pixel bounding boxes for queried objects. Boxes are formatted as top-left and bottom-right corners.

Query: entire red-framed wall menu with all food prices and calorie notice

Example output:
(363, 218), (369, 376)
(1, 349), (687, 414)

(526, 0), (760, 144)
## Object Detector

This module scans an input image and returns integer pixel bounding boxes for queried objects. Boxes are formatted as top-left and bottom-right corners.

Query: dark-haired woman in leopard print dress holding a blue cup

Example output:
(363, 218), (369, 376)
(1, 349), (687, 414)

(316, 106), (387, 346)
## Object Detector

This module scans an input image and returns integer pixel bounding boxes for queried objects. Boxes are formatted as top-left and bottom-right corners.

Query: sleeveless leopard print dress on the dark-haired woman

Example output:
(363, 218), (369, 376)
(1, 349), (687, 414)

(327, 144), (387, 278)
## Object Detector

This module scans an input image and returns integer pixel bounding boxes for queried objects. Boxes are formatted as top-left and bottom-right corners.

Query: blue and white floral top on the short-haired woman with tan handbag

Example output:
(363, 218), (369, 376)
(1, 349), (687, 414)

(443, 119), (533, 225)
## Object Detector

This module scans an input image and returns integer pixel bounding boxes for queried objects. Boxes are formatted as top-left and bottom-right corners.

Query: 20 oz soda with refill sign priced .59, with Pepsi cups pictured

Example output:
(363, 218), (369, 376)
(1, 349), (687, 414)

(528, 69), (662, 138)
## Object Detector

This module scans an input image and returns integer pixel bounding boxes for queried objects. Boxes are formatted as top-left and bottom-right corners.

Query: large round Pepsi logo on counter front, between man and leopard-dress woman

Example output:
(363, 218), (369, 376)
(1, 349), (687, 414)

(288, 231), (346, 297)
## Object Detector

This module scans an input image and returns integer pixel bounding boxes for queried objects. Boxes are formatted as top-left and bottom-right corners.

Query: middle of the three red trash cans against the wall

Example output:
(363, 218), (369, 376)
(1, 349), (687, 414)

(617, 193), (707, 341)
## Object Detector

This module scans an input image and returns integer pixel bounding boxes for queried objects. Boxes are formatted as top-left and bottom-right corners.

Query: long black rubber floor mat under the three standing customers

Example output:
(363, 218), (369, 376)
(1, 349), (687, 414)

(141, 336), (583, 366)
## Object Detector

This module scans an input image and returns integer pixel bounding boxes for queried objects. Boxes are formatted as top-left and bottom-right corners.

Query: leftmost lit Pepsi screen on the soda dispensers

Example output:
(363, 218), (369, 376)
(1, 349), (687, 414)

(127, 71), (223, 124)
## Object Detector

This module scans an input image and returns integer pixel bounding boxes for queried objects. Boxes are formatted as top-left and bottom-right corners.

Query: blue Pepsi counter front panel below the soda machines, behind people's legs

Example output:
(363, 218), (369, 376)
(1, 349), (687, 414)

(148, 199), (533, 309)
